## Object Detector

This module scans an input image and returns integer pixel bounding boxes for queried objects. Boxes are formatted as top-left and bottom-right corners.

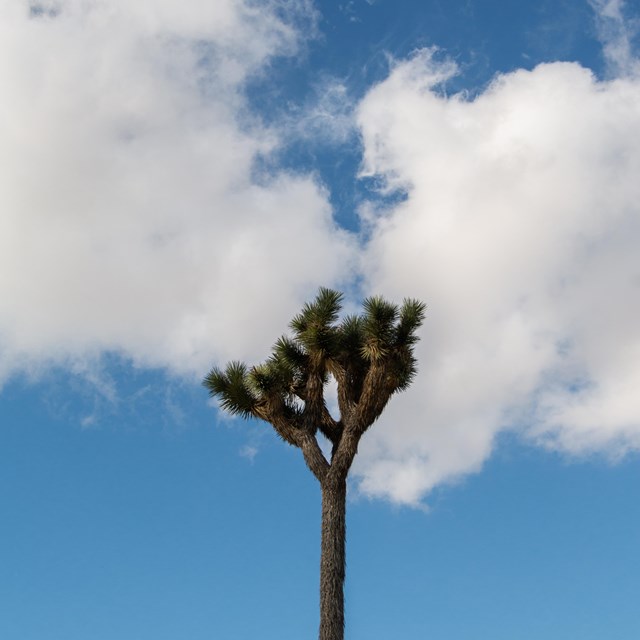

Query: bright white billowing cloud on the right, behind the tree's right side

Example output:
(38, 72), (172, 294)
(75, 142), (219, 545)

(358, 45), (640, 503)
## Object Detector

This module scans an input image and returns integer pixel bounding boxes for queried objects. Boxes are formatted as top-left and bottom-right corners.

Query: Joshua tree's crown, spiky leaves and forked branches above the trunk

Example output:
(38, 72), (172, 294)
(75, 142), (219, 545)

(203, 288), (425, 475)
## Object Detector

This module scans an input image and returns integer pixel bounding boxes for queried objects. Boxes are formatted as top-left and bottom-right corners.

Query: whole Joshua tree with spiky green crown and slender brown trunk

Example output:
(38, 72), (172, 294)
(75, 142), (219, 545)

(204, 288), (425, 640)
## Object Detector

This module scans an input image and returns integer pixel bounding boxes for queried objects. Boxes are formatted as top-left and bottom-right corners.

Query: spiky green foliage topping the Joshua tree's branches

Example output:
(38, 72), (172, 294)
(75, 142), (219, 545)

(204, 288), (425, 430)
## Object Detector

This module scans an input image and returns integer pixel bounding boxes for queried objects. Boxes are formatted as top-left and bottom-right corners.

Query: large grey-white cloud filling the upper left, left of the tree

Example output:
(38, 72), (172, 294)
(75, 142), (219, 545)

(0, 0), (351, 378)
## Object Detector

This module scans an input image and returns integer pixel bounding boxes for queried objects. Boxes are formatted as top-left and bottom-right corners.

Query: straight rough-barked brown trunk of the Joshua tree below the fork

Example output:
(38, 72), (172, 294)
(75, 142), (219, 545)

(319, 478), (347, 640)
